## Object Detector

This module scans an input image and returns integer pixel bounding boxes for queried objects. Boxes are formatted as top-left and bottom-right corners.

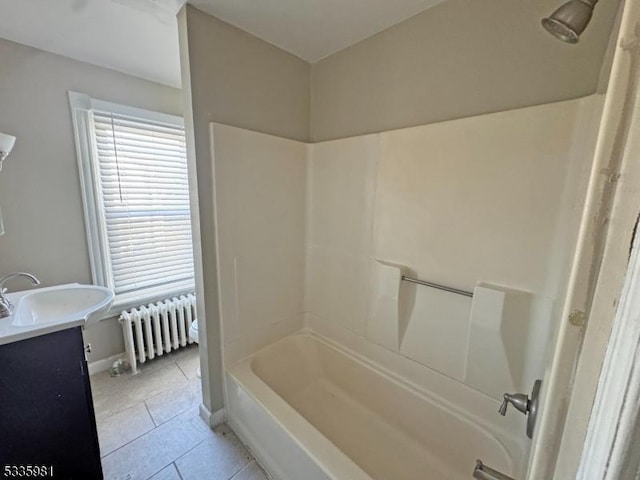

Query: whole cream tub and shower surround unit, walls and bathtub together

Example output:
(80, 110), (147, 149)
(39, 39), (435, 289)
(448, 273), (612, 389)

(211, 96), (601, 479)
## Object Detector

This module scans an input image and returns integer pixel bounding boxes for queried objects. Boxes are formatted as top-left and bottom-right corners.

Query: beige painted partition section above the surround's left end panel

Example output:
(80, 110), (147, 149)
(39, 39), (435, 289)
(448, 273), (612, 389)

(181, 6), (311, 141)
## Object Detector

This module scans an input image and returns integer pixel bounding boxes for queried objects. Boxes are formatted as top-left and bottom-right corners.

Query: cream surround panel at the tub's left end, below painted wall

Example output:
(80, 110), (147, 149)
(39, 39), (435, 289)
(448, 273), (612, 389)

(211, 123), (307, 364)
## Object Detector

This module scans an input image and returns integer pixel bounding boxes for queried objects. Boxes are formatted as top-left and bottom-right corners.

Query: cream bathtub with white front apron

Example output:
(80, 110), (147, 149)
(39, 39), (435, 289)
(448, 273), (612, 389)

(227, 333), (520, 480)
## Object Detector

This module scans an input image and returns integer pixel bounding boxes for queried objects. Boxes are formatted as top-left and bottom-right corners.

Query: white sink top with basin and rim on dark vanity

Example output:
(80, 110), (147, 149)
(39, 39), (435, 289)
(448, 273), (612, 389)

(0, 283), (114, 345)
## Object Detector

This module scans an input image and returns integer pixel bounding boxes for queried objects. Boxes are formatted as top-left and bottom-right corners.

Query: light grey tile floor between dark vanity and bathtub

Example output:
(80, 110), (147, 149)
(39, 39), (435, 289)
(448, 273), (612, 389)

(91, 345), (267, 480)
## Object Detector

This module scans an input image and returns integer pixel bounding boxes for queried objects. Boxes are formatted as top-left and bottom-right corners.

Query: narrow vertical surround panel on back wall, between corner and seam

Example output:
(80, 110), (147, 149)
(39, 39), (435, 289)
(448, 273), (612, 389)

(305, 135), (380, 335)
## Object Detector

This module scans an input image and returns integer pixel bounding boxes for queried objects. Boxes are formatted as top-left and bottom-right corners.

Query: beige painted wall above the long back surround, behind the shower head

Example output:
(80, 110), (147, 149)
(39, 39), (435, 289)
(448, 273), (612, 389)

(311, 0), (619, 141)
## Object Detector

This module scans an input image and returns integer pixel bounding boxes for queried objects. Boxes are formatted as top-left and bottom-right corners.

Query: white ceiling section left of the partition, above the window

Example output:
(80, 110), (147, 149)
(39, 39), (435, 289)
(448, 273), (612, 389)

(0, 0), (180, 86)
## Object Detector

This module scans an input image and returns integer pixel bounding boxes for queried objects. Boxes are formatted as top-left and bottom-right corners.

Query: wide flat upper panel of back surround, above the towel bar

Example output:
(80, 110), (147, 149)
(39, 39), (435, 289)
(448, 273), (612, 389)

(374, 100), (582, 294)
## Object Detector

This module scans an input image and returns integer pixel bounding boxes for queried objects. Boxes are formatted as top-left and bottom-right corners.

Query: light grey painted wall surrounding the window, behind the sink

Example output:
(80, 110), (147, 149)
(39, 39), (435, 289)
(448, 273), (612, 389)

(0, 39), (182, 360)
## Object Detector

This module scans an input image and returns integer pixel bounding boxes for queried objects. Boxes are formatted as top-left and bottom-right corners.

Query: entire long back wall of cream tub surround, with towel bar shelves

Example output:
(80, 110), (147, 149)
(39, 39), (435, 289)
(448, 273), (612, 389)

(305, 97), (599, 406)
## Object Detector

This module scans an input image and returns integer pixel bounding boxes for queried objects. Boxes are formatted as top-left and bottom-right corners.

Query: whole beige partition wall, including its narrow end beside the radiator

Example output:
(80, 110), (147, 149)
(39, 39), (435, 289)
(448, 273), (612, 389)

(178, 5), (311, 416)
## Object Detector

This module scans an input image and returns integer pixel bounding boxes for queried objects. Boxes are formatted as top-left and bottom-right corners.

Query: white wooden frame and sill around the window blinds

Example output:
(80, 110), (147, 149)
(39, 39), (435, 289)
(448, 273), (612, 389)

(68, 91), (195, 318)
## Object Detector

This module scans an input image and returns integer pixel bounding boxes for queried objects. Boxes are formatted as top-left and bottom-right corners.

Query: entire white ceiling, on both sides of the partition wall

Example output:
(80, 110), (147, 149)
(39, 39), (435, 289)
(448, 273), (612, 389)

(0, 0), (443, 87)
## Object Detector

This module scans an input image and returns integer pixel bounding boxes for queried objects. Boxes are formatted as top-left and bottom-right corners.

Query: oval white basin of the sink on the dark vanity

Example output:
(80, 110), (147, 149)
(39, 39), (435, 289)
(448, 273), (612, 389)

(11, 284), (114, 327)
